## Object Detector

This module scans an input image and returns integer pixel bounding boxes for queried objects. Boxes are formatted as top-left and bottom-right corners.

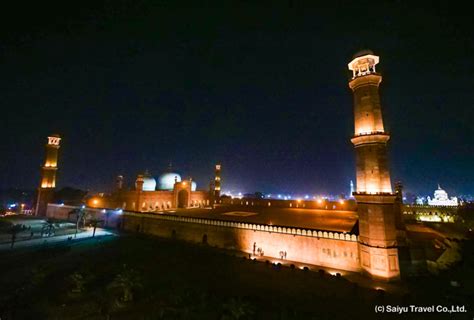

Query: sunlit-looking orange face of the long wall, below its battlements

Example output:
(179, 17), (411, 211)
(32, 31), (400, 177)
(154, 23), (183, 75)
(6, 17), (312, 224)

(122, 215), (361, 271)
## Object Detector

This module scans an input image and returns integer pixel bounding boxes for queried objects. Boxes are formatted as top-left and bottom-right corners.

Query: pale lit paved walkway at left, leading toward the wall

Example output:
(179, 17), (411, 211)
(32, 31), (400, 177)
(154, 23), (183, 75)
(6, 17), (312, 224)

(0, 228), (115, 251)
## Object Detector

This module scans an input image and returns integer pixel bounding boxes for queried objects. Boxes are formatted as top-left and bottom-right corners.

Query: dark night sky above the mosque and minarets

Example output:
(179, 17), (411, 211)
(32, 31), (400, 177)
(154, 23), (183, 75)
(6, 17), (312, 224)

(0, 0), (474, 194)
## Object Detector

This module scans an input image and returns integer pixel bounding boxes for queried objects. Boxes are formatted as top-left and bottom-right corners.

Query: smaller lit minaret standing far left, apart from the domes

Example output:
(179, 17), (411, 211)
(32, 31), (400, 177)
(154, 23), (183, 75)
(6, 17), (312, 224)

(35, 134), (61, 216)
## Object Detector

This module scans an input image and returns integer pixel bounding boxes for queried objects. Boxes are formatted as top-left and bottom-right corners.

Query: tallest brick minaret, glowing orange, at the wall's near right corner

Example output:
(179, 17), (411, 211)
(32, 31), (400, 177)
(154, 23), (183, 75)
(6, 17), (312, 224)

(348, 51), (400, 280)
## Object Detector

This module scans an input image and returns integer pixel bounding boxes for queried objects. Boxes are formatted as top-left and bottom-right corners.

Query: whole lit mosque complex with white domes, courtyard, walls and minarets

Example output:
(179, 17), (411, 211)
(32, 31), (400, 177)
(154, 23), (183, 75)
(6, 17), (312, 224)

(32, 51), (460, 280)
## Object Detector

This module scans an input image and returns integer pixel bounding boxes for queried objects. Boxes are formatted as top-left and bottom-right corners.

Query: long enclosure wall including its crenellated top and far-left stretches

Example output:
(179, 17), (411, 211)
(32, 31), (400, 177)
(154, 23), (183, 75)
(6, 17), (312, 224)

(48, 205), (361, 271)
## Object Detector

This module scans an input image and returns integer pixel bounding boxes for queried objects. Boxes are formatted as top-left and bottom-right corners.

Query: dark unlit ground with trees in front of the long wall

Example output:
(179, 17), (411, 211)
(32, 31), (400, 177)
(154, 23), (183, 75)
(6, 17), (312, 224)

(0, 235), (472, 320)
